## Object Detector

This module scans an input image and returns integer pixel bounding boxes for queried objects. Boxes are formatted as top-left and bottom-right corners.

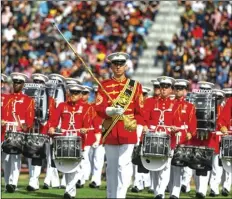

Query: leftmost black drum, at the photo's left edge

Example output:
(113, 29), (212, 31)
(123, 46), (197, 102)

(2, 131), (25, 154)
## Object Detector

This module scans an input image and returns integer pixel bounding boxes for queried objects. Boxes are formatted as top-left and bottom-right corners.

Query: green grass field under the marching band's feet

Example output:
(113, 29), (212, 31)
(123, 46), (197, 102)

(1, 174), (232, 199)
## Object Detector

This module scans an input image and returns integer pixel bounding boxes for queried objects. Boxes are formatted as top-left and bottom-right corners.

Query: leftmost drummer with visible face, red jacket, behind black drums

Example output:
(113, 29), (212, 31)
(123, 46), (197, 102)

(2, 72), (35, 193)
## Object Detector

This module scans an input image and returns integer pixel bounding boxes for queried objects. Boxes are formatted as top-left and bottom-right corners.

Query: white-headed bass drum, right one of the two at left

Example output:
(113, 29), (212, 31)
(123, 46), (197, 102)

(46, 80), (66, 107)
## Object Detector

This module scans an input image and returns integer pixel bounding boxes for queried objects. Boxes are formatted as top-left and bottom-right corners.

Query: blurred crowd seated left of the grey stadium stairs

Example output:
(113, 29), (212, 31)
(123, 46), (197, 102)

(1, 1), (159, 87)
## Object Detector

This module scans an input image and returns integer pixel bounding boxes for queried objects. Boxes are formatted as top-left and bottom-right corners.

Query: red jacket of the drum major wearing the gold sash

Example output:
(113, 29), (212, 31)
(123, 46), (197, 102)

(96, 78), (144, 145)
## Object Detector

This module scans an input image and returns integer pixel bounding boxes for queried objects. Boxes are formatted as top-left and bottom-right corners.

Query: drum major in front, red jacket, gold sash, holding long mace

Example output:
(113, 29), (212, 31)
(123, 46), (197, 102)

(96, 52), (144, 198)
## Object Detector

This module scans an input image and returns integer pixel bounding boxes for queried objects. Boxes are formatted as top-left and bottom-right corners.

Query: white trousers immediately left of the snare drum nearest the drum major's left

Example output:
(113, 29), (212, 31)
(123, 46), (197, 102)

(44, 144), (60, 187)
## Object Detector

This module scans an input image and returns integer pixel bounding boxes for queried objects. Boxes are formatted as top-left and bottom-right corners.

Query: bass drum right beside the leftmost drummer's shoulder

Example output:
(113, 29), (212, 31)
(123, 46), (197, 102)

(22, 83), (49, 123)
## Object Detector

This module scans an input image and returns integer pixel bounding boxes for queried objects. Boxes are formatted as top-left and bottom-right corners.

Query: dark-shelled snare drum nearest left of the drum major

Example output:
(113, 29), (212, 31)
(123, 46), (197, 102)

(53, 136), (82, 161)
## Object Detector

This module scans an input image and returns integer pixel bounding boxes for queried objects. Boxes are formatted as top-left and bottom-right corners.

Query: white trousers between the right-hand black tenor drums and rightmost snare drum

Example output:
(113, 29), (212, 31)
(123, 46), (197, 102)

(209, 155), (223, 194)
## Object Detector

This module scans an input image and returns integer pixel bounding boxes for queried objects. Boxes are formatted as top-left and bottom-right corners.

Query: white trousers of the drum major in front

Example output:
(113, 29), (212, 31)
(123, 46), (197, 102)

(105, 144), (134, 198)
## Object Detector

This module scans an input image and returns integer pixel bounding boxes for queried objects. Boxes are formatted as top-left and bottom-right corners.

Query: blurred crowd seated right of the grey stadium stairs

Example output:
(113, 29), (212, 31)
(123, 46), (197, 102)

(159, 1), (232, 88)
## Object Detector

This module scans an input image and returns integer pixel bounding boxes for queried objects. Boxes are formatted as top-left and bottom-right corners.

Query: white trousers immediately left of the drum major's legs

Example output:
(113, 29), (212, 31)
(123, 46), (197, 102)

(91, 145), (105, 186)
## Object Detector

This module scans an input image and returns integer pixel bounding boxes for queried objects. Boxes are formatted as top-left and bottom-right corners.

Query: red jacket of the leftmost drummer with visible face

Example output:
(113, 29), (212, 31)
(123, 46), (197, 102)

(2, 92), (35, 139)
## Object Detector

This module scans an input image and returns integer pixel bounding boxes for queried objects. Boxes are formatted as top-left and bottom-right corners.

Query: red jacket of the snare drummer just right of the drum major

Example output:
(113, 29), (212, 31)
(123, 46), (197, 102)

(145, 97), (175, 148)
